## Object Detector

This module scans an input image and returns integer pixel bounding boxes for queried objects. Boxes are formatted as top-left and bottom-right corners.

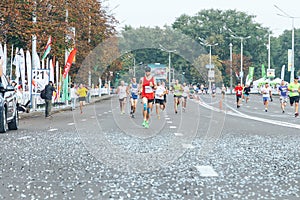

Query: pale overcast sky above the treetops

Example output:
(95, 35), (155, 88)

(105, 0), (300, 36)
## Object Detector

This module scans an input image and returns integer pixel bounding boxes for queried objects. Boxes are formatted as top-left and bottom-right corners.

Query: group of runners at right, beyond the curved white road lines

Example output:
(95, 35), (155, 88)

(234, 76), (300, 117)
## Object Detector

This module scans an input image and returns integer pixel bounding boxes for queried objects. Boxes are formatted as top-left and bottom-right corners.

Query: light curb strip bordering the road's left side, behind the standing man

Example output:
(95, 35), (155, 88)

(19, 95), (113, 119)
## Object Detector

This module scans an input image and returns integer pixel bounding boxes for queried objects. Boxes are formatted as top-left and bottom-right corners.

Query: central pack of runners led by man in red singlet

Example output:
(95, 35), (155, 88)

(117, 66), (189, 128)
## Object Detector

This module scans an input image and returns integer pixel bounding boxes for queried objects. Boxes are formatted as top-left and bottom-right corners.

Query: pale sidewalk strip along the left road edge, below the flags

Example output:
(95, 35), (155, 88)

(19, 95), (113, 119)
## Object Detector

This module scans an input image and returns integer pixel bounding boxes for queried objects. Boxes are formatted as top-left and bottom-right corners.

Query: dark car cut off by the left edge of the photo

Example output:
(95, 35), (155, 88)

(0, 75), (19, 133)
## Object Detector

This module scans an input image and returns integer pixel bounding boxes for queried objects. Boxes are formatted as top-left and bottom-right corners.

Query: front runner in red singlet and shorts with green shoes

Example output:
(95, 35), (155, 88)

(139, 66), (156, 128)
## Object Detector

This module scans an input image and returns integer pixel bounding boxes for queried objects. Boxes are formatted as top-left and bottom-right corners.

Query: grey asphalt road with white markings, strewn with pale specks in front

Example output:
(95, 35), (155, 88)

(0, 95), (300, 199)
